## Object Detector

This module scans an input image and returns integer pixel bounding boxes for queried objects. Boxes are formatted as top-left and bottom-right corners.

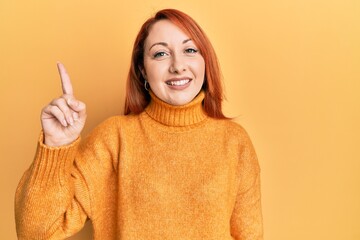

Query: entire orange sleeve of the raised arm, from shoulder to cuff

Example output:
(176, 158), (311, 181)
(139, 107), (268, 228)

(15, 117), (120, 240)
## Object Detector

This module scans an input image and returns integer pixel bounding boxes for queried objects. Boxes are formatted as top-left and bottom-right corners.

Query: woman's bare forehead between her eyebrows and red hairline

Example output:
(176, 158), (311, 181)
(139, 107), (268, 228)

(145, 20), (190, 46)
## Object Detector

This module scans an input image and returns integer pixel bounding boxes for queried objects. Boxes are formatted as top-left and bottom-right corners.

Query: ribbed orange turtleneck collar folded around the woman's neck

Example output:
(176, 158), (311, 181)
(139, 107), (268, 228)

(145, 91), (207, 127)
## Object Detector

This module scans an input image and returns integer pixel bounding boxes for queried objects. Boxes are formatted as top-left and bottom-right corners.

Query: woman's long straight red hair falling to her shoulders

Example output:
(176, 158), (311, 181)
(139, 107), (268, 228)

(124, 9), (226, 119)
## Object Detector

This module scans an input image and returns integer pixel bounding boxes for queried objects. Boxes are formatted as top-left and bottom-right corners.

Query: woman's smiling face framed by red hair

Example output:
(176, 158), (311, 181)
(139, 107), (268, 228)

(142, 20), (205, 105)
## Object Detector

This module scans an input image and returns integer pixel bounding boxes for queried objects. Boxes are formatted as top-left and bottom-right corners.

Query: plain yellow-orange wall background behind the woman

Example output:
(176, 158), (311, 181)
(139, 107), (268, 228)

(0, 0), (360, 240)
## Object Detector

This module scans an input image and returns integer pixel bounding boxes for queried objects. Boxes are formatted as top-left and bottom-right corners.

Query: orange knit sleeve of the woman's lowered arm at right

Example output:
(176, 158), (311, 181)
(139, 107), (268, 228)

(230, 131), (263, 240)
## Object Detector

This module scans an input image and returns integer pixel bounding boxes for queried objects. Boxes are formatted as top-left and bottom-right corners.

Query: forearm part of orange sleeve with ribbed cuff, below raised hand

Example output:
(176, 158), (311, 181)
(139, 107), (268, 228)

(15, 135), (89, 239)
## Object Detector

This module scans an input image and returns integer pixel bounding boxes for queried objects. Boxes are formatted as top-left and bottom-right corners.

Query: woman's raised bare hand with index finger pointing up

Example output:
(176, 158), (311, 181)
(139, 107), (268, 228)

(41, 63), (86, 147)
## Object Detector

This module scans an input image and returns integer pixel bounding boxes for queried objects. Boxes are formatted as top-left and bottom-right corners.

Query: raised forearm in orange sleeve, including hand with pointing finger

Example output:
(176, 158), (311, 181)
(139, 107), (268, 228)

(15, 63), (90, 239)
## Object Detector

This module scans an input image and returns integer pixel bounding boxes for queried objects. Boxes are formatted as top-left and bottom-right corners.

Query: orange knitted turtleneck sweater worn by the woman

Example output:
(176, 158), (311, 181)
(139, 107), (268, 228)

(15, 92), (263, 240)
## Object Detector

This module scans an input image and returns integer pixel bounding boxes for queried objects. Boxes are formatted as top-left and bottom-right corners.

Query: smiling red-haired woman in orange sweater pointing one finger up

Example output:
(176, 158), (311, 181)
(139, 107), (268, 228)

(16, 9), (262, 240)
